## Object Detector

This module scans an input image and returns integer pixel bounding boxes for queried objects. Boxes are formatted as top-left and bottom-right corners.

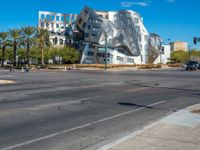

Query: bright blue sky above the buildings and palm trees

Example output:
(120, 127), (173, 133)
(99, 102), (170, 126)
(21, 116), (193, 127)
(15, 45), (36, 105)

(0, 0), (200, 48)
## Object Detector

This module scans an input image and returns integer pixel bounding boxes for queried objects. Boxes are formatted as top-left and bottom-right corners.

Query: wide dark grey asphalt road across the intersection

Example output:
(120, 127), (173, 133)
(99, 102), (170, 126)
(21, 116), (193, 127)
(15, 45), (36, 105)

(0, 70), (200, 150)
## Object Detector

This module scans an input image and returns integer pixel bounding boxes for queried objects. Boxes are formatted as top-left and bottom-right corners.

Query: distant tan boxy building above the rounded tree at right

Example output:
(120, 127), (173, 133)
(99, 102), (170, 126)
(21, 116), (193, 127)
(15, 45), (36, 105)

(170, 41), (188, 52)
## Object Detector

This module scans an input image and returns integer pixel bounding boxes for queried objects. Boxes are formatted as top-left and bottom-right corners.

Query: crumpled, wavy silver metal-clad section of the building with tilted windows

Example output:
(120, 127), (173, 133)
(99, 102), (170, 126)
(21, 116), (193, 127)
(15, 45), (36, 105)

(77, 7), (154, 64)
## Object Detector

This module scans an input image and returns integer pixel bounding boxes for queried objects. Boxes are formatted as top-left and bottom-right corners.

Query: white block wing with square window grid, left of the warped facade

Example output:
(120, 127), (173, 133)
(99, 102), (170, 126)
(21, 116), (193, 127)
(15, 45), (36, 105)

(38, 11), (77, 46)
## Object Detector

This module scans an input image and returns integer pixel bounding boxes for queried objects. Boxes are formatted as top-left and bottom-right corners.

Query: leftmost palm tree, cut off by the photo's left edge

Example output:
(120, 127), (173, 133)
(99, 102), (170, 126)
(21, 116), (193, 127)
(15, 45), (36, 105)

(0, 32), (8, 67)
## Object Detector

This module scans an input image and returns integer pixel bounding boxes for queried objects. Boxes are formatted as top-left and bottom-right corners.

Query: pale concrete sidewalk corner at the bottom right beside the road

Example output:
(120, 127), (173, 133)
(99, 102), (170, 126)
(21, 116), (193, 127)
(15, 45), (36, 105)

(99, 105), (200, 150)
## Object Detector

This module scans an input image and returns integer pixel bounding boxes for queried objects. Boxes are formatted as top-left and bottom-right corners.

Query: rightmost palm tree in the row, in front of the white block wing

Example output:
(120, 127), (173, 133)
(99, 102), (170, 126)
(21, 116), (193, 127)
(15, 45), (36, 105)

(37, 28), (50, 66)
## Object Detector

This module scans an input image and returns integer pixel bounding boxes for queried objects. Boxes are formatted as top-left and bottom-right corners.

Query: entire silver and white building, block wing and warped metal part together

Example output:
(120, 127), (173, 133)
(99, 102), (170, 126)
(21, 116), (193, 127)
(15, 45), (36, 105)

(38, 6), (166, 64)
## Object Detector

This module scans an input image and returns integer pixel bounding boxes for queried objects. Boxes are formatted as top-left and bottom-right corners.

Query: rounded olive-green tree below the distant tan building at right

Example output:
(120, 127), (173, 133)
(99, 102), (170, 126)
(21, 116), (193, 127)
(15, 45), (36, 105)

(170, 50), (189, 63)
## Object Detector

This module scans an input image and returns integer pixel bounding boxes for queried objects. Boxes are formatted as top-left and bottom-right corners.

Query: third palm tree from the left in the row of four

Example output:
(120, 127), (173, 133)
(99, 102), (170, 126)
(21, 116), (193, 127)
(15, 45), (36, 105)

(21, 26), (35, 65)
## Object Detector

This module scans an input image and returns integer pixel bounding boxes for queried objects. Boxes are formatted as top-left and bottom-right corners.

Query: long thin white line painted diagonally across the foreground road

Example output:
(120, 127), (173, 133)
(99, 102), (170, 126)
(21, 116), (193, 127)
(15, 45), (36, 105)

(1, 101), (166, 150)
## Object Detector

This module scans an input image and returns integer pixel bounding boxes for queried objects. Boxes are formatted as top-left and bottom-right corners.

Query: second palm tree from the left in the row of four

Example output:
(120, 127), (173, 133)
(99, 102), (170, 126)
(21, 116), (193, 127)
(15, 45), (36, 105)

(9, 29), (21, 66)
